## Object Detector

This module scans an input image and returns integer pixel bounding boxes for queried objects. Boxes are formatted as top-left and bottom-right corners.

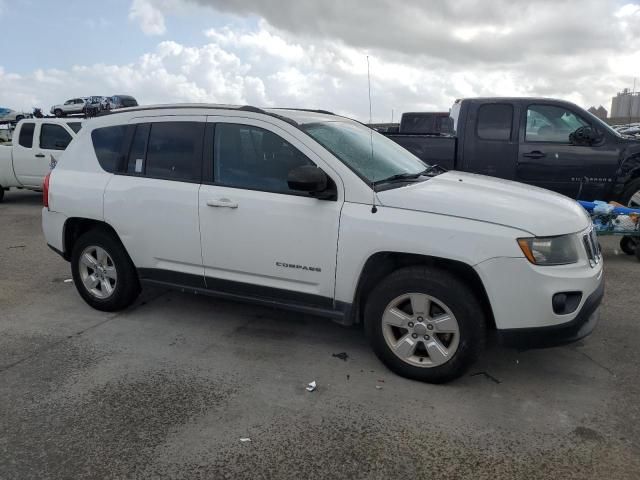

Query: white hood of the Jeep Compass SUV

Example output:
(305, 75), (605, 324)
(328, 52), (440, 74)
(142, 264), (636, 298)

(378, 171), (591, 237)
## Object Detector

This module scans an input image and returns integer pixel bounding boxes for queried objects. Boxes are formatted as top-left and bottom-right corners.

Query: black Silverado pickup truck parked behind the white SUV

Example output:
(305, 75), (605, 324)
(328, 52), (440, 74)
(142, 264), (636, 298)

(383, 98), (640, 206)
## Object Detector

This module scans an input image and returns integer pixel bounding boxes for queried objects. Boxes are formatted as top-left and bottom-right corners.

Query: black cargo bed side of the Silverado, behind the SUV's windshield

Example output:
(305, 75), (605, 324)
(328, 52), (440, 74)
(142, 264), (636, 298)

(384, 133), (456, 170)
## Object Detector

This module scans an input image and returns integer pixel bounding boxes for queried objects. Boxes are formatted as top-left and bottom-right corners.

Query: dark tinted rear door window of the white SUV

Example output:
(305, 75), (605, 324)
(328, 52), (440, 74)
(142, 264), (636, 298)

(132, 122), (205, 182)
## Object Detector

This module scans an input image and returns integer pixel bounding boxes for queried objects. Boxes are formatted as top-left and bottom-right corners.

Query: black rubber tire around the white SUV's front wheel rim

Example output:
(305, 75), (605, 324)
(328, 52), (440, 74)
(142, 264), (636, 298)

(364, 267), (486, 383)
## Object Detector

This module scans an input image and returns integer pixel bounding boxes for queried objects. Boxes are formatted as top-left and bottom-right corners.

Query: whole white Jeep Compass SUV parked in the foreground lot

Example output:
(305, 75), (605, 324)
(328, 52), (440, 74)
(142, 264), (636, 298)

(42, 105), (604, 382)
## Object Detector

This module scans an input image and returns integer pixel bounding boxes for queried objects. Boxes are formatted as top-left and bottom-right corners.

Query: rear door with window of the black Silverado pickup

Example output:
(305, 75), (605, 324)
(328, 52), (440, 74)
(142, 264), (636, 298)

(462, 103), (518, 180)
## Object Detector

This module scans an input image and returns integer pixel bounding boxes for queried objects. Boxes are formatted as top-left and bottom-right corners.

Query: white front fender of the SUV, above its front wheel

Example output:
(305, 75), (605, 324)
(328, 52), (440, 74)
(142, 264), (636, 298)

(336, 203), (529, 303)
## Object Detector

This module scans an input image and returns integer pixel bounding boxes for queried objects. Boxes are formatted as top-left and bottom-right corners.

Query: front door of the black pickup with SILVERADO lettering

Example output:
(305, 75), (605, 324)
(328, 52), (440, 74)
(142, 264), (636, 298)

(516, 103), (619, 200)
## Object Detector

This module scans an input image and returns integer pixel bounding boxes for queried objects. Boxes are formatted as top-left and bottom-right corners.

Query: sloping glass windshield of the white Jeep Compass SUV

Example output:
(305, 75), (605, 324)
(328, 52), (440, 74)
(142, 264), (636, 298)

(301, 121), (427, 183)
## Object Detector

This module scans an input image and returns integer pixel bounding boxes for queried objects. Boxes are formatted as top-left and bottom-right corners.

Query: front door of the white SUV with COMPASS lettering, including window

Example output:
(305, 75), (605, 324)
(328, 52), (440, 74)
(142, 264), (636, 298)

(199, 117), (343, 308)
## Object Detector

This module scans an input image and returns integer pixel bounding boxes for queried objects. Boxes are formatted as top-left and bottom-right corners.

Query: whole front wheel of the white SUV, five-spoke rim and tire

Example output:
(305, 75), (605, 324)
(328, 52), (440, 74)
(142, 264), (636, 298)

(365, 267), (486, 383)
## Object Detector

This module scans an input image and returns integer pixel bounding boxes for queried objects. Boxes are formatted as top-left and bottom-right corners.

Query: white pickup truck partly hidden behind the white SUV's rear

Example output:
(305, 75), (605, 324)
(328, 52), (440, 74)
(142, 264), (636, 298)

(0, 118), (82, 202)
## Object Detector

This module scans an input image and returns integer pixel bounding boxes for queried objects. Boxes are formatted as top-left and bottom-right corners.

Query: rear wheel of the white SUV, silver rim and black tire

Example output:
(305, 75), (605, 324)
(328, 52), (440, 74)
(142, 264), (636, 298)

(71, 229), (140, 312)
